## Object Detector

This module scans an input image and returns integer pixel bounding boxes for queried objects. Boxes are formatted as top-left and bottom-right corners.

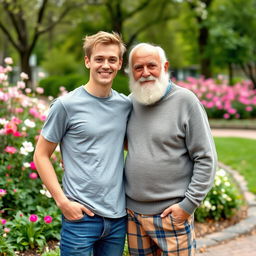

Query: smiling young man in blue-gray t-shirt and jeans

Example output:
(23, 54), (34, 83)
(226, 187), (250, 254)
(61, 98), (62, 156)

(34, 32), (132, 256)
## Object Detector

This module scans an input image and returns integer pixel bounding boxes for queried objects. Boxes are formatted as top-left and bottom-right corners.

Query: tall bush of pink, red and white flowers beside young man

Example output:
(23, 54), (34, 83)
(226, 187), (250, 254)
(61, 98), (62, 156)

(0, 58), (62, 255)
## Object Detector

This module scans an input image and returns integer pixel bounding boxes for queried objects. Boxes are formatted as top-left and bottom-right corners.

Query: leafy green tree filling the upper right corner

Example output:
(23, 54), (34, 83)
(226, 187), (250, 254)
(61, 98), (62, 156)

(211, 0), (256, 88)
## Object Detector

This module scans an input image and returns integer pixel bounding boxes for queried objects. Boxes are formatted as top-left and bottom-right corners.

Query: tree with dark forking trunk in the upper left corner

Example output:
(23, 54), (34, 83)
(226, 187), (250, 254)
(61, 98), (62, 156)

(0, 0), (86, 86)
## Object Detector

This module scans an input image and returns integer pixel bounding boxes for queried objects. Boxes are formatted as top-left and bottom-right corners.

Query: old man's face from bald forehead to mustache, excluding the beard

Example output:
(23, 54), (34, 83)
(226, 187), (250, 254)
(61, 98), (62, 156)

(132, 47), (162, 86)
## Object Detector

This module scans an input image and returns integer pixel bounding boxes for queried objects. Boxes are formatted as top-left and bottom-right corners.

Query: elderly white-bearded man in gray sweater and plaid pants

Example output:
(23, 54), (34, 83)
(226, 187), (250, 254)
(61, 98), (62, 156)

(125, 44), (217, 256)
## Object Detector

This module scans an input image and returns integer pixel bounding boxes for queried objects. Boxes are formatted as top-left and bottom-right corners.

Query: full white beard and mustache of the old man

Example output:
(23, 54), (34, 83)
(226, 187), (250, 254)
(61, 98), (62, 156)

(129, 69), (169, 105)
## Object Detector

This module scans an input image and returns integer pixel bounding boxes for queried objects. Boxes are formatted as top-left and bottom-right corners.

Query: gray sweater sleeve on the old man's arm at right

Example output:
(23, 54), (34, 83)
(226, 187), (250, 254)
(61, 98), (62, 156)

(179, 101), (217, 214)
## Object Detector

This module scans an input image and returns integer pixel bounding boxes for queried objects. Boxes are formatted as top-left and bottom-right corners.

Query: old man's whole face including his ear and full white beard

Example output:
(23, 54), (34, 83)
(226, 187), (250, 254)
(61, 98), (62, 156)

(129, 47), (169, 105)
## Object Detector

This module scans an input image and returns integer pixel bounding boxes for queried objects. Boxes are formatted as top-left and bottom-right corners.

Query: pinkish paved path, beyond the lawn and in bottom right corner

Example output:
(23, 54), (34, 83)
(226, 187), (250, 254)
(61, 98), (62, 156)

(197, 129), (256, 256)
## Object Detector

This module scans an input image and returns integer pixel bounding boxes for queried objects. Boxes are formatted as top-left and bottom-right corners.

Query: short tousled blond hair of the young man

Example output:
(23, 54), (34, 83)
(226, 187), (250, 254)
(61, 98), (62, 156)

(83, 31), (126, 58)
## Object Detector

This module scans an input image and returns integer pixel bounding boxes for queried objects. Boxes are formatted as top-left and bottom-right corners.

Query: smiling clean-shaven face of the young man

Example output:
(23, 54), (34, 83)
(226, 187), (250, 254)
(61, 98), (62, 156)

(85, 44), (122, 86)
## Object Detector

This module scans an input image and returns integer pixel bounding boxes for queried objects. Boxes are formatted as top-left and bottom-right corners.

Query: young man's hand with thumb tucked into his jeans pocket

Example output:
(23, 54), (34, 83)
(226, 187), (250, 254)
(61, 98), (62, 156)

(59, 200), (94, 220)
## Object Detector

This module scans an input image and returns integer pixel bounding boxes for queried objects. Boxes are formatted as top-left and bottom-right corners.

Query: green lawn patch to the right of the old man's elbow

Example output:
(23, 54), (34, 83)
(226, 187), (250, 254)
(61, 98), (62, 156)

(214, 137), (256, 194)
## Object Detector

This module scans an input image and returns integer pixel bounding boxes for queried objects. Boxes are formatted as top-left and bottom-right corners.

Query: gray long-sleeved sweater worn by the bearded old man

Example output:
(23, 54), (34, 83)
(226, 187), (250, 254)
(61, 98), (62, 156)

(125, 83), (217, 214)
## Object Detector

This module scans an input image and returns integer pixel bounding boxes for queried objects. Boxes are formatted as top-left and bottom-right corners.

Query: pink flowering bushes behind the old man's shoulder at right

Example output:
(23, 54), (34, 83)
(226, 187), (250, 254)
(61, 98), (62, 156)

(177, 76), (256, 119)
